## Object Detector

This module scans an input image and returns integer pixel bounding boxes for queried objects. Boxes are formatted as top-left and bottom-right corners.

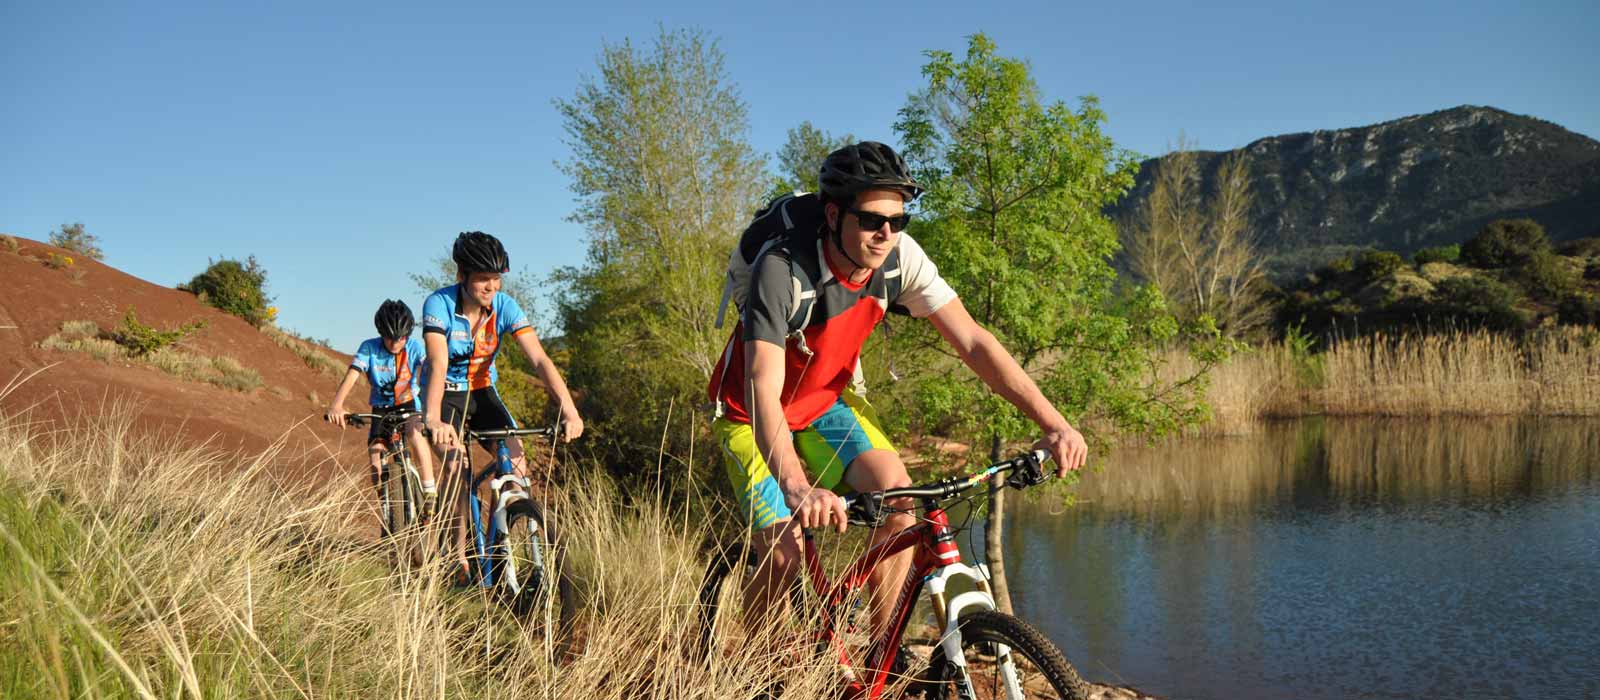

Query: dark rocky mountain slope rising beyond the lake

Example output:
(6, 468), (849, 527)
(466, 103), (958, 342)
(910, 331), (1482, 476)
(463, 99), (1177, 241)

(1115, 105), (1600, 278)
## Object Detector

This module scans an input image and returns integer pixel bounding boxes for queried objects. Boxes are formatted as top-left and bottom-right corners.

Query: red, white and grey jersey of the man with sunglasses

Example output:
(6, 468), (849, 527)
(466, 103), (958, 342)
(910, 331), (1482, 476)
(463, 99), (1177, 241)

(709, 233), (955, 430)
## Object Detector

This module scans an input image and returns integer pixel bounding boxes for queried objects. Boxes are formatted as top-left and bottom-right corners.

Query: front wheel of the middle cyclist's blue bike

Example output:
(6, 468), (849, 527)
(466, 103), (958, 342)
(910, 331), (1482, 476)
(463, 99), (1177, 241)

(491, 499), (576, 628)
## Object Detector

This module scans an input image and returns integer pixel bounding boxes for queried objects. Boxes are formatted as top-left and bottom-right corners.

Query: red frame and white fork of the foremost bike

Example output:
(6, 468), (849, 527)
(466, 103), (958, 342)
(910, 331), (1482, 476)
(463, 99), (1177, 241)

(805, 500), (995, 698)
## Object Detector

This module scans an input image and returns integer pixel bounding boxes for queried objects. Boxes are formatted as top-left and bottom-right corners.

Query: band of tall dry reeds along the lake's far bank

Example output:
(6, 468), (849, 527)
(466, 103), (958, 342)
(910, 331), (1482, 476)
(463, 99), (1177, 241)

(1166, 326), (1600, 435)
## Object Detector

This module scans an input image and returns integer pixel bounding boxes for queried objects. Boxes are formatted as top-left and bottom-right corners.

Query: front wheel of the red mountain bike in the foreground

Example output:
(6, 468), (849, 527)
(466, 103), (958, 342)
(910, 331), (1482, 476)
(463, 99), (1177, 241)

(917, 611), (1090, 700)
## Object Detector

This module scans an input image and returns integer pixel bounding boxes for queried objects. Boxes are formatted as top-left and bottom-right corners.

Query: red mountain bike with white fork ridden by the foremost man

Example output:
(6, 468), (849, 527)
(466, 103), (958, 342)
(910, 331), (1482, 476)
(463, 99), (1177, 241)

(699, 451), (1088, 700)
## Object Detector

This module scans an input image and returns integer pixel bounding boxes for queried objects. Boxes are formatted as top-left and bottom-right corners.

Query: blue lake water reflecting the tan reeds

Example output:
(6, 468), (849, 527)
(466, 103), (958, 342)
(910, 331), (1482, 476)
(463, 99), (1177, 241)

(1006, 419), (1600, 698)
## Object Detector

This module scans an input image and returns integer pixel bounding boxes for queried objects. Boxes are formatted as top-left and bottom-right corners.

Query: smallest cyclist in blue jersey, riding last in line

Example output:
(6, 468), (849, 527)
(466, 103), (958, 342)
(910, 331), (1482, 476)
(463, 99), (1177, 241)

(326, 299), (438, 519)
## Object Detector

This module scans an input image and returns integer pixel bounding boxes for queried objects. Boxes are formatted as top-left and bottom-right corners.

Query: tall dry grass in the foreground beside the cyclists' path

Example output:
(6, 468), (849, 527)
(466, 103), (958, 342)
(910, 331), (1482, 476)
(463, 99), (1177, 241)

(0, 385), (889, 700)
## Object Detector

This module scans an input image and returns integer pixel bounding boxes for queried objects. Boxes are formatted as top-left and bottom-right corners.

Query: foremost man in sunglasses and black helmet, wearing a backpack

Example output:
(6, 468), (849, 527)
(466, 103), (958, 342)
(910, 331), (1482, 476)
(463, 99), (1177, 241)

(709, 141), (1088, 639)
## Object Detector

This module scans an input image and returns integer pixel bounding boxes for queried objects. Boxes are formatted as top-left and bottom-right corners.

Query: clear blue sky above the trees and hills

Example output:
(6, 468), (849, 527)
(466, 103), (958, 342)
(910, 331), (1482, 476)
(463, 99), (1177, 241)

(0, 0), (1600, 350)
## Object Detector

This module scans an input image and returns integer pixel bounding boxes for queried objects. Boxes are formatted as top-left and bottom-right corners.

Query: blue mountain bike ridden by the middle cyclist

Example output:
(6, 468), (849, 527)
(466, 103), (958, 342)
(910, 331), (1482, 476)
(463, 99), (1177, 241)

(461, 425), (576, 628)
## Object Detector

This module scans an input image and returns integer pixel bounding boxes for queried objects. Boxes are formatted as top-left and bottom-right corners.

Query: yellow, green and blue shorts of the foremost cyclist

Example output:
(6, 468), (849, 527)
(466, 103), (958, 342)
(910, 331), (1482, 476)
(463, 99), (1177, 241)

(710, 388), (894, 529)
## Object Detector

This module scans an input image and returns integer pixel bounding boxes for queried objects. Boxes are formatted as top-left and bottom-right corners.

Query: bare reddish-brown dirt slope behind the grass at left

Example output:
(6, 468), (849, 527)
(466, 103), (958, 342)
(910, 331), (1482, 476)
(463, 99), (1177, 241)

(0, 238), (366, 468)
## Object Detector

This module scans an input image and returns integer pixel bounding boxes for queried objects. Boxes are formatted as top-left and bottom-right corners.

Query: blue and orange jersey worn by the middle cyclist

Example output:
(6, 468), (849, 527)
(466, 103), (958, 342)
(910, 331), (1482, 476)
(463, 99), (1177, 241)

(422, 284), (533, 392)
